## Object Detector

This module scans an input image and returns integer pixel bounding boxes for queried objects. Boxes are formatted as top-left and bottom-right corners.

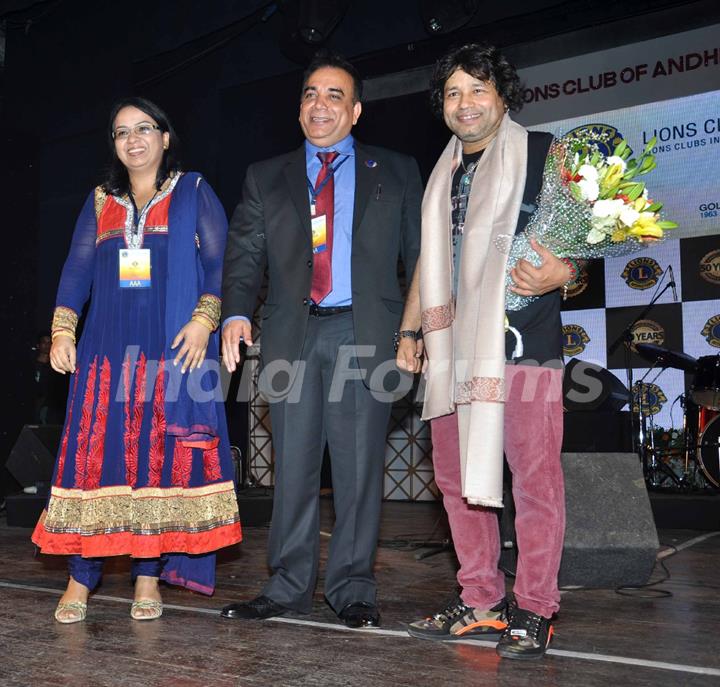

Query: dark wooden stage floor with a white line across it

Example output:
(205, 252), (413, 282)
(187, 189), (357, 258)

(0, 499), (720, 687)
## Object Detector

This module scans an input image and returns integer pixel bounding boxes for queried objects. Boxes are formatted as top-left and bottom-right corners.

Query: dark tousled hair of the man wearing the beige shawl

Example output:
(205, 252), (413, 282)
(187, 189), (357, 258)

(430, 43), (523, 119)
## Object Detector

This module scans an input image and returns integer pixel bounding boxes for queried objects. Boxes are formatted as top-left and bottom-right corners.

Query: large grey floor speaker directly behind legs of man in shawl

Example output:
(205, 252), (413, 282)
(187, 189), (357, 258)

(500, 453), (659, 589)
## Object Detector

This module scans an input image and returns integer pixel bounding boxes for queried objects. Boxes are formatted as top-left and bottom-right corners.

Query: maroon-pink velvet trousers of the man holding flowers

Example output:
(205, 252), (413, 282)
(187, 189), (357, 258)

(431, 365), (565, 618)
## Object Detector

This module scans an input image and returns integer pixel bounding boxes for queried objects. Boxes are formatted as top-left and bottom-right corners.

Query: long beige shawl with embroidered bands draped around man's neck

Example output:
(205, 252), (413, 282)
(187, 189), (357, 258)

(420, 114), (527, 508)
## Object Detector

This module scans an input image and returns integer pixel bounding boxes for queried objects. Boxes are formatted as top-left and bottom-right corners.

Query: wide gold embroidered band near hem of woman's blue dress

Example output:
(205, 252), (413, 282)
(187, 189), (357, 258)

(44, 482), (239, 536)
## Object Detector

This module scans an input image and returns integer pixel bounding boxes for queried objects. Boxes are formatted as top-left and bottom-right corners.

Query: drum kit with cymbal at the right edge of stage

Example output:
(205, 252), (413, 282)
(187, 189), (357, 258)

(633, 344), (720, 490)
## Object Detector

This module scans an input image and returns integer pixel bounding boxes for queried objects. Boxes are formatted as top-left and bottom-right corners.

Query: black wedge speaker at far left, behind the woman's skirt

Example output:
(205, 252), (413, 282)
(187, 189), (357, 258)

(5, 425), (62, 487)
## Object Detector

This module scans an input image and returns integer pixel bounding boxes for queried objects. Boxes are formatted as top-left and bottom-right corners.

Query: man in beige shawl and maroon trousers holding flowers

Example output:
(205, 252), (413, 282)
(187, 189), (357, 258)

(397, 44), (573, 659)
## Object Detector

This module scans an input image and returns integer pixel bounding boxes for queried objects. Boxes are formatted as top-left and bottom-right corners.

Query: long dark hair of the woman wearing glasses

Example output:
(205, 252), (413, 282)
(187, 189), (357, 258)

(101, 96), (180, 196)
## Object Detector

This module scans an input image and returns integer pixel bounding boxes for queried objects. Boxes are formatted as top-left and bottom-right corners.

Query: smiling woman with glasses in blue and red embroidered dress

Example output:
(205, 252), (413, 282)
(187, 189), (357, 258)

(33, 98), (241, 623)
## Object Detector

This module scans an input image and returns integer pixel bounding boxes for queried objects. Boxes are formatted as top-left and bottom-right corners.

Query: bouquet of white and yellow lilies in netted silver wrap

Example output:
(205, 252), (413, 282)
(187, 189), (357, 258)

(498, 129), (677, 311)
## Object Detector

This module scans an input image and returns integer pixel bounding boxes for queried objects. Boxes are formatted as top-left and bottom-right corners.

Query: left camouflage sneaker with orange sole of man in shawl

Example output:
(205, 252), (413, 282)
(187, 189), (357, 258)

(407, 595), (508, 642)
